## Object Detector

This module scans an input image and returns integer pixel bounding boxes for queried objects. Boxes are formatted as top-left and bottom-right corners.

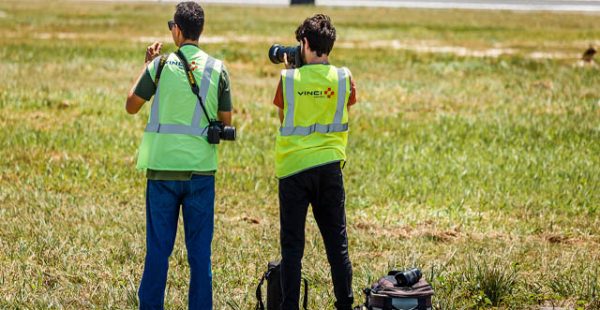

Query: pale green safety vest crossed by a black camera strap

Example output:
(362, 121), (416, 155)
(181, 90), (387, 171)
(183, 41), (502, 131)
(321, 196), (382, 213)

(137, 45), (223, 171)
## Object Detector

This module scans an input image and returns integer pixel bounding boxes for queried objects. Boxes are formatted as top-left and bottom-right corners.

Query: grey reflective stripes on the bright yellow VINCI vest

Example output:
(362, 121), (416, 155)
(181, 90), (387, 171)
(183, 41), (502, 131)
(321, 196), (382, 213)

(279, 68), (348, 136)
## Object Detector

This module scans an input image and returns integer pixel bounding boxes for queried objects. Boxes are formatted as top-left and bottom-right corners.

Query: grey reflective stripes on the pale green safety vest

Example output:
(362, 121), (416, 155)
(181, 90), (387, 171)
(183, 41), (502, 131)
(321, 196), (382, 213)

(145, 57), (223, 137)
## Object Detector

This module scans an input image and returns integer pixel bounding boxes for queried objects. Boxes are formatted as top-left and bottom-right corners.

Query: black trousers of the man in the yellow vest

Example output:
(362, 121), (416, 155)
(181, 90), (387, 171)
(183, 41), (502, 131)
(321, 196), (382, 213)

(279, 162), (354, 310)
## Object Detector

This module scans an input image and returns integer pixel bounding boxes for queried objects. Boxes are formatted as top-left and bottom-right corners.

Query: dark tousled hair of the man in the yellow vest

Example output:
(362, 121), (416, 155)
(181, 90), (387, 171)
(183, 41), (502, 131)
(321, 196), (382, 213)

(296, 14), (335, 57)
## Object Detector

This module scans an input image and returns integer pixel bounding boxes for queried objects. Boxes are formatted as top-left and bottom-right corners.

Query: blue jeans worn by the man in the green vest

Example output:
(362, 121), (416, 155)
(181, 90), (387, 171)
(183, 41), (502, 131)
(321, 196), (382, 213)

(138, 175), (215, 310)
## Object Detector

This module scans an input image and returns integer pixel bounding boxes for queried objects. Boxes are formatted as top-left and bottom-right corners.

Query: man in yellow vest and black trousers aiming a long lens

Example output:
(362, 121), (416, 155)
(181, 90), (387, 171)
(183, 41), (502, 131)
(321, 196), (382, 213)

(273, 14), (356, 310)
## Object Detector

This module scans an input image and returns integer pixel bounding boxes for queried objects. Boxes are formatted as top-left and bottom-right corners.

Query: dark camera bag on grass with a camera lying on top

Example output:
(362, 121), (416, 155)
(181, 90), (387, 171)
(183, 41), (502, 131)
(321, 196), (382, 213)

(364, 276), (434, 310)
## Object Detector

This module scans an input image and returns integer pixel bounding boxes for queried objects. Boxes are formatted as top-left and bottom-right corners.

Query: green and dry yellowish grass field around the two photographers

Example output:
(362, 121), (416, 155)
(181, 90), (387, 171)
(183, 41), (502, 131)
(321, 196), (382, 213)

(0, 0), (600, 309)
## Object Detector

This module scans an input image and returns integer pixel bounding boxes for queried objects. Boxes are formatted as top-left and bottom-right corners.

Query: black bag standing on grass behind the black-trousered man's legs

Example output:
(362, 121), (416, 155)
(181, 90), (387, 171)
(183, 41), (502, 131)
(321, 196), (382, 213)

(255, 261), (308, 310)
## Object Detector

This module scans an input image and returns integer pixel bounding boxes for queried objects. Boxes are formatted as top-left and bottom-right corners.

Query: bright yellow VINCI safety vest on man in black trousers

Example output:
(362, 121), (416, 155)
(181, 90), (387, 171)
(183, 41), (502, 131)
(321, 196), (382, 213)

(275, 64), (351, 178)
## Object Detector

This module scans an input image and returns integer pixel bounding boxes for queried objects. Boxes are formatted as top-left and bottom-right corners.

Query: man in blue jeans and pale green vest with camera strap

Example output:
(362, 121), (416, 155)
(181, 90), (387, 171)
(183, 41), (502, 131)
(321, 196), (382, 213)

(126, 2), (232, 310)
